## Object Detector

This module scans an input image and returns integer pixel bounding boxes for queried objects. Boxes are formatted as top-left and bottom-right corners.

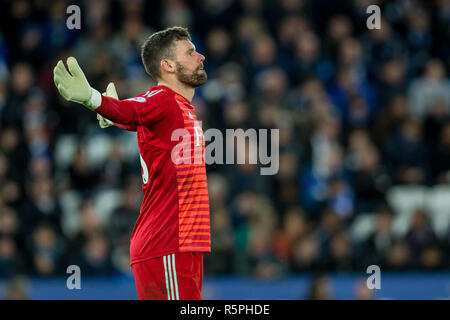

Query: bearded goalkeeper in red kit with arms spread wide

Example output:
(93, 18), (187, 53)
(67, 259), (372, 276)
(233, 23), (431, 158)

(54, 27), (211, 300)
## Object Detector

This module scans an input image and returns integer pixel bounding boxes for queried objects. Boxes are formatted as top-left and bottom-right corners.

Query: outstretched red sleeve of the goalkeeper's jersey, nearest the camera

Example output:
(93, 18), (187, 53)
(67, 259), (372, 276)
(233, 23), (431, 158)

(94, 90), (166, 127)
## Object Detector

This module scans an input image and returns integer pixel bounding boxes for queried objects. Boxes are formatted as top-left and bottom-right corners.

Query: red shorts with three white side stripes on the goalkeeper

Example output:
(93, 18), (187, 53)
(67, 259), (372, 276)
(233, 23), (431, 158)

(131, 252), (203, 300)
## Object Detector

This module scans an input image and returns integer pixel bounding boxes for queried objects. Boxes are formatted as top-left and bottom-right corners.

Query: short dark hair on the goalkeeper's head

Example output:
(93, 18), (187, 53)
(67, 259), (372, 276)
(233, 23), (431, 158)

(141, 27), (191, 81)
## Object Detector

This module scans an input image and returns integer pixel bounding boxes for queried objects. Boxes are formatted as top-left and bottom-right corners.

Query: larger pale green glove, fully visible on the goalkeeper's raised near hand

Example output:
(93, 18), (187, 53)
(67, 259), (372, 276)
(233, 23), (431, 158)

(53, 57), (102, 110)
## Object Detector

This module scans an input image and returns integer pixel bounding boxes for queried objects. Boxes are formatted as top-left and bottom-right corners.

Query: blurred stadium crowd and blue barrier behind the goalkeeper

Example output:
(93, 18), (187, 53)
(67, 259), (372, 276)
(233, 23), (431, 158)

(0, 0), (450, 299)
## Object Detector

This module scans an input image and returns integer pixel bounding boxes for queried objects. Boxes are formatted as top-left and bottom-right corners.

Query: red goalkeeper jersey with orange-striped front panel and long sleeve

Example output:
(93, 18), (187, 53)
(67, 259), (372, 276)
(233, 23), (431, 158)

(95, 86), (211, 264)
